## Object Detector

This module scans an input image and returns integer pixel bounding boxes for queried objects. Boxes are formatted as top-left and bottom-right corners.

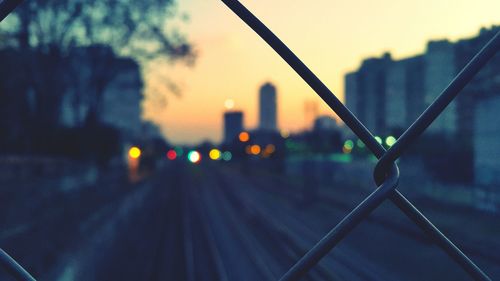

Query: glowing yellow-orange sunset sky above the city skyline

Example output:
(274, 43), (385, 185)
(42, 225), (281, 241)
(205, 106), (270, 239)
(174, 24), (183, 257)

(144, 0), (500, 143)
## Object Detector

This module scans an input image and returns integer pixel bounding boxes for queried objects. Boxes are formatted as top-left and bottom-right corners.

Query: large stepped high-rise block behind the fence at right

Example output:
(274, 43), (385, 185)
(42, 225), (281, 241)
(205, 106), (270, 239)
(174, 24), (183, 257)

(345, 26), (500, 137)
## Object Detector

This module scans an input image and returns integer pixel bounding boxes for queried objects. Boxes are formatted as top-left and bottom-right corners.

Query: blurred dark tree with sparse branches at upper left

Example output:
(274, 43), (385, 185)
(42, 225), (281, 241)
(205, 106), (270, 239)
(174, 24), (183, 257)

(0, 0), (195, 125)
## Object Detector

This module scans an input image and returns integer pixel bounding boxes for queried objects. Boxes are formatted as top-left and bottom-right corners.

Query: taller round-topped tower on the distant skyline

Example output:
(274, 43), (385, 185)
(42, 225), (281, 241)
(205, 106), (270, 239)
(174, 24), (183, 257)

(259, 83), (278, 131)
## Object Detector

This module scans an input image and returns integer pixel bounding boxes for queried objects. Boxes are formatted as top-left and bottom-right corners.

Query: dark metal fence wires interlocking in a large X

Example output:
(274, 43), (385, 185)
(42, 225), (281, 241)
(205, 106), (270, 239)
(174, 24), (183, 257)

(221, 0), (499, 281)
